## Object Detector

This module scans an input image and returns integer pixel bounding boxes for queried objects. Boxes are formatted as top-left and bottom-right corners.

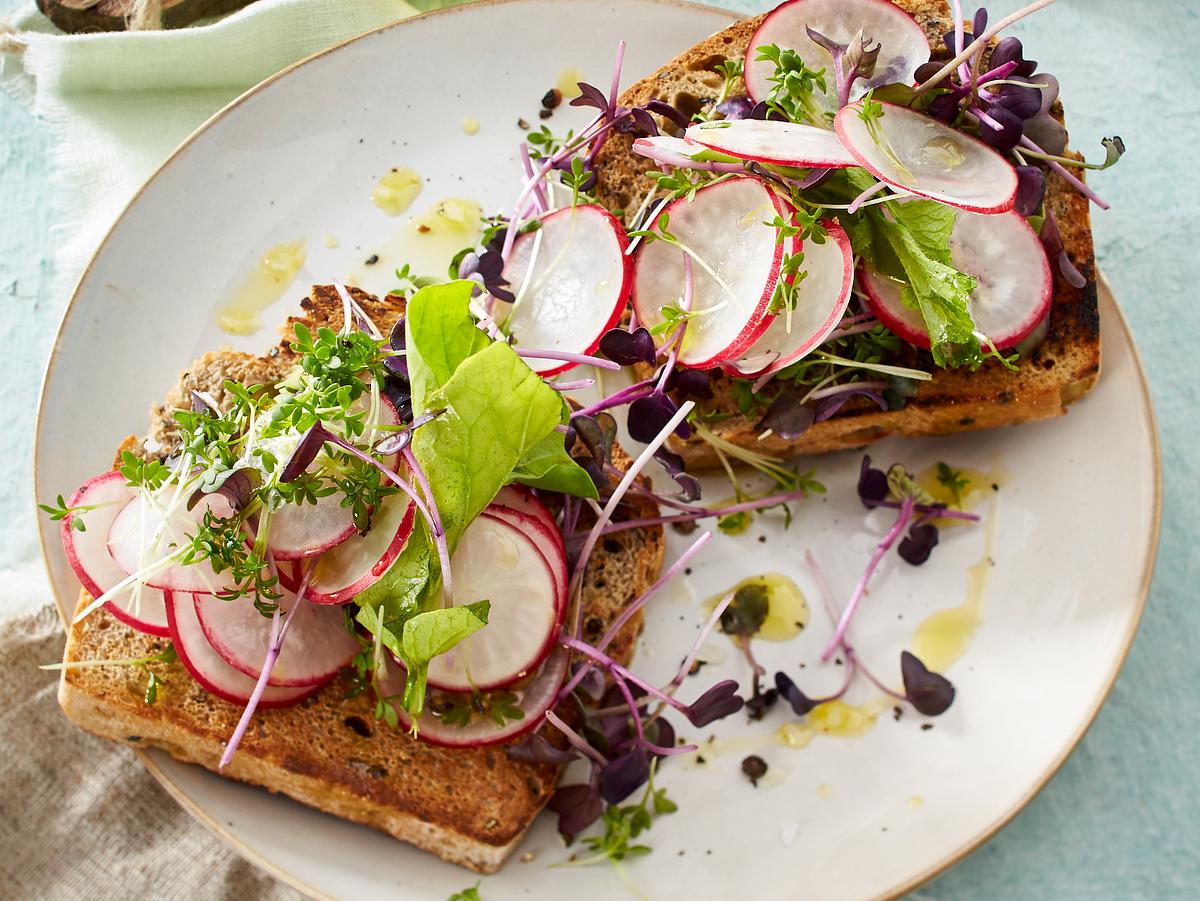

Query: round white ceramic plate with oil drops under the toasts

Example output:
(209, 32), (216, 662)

(36, 0), (1158, 901)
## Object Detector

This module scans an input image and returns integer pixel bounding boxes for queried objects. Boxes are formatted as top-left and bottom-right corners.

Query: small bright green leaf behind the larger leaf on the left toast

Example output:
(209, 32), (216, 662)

(404, 281), (491, 414)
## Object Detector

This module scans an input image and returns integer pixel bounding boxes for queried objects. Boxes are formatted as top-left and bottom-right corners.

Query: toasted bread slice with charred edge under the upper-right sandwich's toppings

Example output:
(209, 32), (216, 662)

(596, 0), (1100, 470)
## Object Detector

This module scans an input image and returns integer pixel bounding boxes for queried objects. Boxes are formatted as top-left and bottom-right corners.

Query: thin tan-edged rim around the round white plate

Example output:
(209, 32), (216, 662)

(31, 0), (1163, 901)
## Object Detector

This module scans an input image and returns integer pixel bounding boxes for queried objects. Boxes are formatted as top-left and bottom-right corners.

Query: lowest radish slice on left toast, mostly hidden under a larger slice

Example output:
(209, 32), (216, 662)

(383, 647), (570, 747)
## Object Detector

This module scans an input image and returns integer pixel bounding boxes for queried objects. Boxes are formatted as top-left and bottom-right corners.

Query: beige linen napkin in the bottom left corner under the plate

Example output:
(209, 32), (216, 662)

(0, 607), (302, 901)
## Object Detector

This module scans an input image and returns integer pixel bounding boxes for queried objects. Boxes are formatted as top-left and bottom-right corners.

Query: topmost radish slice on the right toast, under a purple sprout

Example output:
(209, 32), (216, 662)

(745, 0), (929, 109)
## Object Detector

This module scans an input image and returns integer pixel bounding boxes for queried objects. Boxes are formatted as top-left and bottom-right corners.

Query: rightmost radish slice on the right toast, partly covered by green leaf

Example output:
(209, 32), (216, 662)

(859, 211), (1054, 349)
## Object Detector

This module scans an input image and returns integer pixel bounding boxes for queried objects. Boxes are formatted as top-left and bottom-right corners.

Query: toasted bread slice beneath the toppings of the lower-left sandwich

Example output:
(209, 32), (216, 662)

(59, 287), (665, 872)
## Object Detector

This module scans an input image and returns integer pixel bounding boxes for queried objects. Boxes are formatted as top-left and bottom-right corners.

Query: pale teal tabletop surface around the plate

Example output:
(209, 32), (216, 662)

(0, 0), (1200, 900)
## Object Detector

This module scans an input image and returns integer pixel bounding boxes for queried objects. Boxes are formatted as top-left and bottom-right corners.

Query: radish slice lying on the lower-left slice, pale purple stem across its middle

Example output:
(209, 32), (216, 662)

(192, 591), (362, 687)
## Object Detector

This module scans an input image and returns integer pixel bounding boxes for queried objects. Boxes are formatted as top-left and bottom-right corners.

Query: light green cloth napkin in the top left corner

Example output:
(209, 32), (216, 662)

(0, 0), (432, 316)
